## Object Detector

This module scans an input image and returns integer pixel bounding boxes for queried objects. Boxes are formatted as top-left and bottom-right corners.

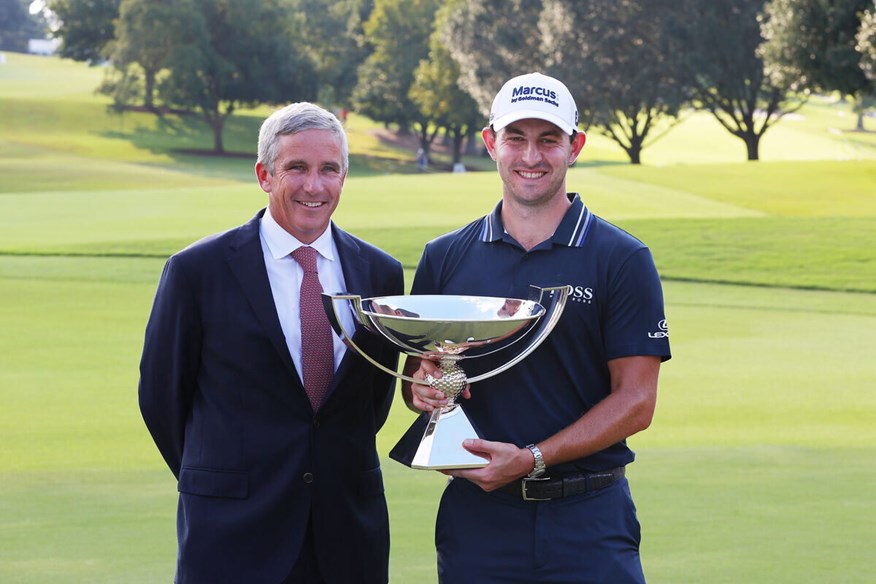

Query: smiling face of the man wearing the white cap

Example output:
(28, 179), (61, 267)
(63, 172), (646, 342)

(482, 119), (584, 206)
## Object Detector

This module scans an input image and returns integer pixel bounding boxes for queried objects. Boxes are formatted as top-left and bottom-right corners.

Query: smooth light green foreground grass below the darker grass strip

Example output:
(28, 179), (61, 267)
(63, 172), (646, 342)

(0, 266), (876, 583)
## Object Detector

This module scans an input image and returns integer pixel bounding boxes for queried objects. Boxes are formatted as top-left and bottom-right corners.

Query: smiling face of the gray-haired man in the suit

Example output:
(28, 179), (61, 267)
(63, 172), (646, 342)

(256, 130), (346, 243)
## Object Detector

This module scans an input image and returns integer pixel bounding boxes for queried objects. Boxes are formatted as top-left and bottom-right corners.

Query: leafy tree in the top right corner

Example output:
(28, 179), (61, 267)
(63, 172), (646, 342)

(762, 0), (873, 130)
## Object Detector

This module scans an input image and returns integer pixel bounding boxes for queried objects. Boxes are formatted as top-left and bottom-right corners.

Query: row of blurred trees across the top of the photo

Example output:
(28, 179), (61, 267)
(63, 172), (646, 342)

(0, 0), (876, 164)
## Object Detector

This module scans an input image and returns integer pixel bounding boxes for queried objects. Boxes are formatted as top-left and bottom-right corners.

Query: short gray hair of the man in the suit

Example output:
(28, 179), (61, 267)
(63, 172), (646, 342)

(258, 101), (350, 176)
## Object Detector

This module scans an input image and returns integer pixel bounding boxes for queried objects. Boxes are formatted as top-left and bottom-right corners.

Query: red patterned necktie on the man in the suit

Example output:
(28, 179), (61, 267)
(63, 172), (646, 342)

(292, 246), (335, 411)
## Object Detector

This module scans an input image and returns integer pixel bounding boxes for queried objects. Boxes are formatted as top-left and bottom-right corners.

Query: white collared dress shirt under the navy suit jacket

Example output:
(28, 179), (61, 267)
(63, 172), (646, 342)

(259, 208), (353, 383)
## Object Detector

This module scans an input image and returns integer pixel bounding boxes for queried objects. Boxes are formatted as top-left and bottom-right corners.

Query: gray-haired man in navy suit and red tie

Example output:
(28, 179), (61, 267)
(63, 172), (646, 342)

(139, 103), (404, 584)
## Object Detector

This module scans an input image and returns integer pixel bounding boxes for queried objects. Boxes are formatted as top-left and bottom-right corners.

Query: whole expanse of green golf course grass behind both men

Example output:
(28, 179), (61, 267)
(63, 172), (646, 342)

(0, 54), (876, 584)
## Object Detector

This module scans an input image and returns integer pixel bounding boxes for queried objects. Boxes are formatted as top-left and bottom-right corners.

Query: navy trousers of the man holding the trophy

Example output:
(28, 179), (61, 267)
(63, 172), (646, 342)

(435, 479), (645, 584)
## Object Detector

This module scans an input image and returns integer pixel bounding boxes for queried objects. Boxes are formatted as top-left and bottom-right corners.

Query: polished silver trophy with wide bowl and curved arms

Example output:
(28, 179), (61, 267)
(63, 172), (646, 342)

(323, 286), (571, 469)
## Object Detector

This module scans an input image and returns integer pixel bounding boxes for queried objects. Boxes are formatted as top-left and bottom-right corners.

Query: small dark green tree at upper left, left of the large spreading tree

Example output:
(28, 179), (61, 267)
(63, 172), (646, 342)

(49, 0), (121, 63)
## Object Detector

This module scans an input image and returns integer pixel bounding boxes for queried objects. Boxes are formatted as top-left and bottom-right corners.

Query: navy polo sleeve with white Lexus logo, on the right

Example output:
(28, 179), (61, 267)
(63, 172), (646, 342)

(604, 247), (671, 361)
